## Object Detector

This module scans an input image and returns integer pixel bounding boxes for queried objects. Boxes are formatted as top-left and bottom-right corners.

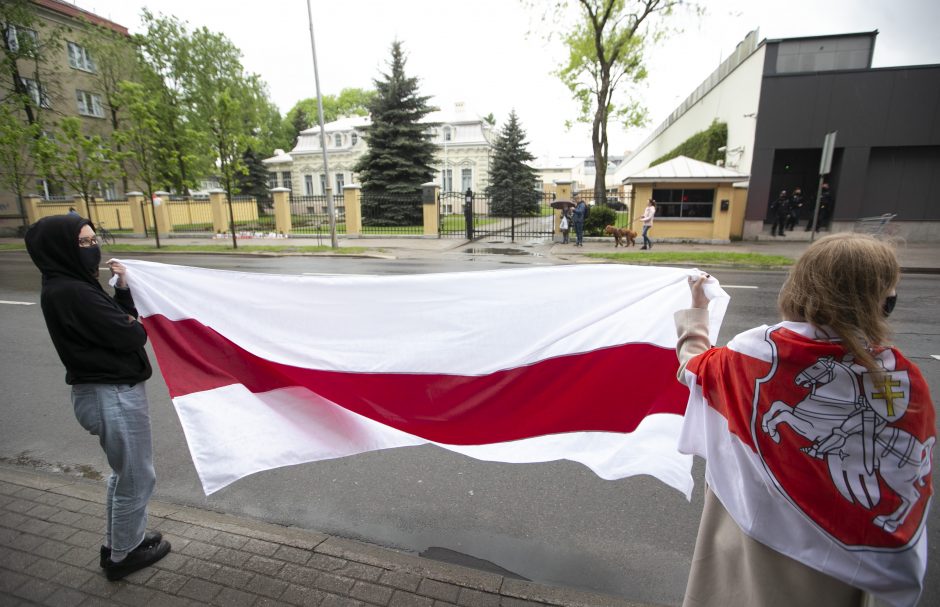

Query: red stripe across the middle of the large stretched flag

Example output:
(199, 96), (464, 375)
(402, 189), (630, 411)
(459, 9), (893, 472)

(145, 315), (688, 445)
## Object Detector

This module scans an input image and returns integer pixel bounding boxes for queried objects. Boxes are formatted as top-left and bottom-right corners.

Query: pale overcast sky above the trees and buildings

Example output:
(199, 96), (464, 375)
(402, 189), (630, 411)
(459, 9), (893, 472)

(74, 0), (940, 156)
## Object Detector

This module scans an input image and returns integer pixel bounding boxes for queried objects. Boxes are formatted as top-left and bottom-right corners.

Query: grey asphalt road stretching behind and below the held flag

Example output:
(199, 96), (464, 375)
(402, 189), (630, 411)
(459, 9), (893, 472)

(0, 252), (940, 605)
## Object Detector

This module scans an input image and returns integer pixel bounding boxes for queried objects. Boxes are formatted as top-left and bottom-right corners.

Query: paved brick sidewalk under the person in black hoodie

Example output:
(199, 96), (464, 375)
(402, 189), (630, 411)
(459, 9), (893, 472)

(0, 465), (644, 607)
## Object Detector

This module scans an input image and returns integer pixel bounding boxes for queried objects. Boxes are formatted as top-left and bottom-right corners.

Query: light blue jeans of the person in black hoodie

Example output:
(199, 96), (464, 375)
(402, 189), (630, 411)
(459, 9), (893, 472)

(72, 383), (156, 560)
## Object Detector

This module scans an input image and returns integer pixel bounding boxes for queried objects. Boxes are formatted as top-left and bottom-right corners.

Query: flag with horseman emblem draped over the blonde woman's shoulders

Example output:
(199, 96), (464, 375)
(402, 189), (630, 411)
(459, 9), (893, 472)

(680, 322), (935, 605)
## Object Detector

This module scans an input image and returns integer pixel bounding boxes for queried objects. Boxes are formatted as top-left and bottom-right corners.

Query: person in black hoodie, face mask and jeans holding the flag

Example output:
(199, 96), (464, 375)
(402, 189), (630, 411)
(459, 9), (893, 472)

(26, 214), (170, 581)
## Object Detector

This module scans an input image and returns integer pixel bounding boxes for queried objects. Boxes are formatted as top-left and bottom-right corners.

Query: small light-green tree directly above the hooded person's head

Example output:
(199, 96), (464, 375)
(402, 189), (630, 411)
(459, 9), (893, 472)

(48, 116), (117, 214)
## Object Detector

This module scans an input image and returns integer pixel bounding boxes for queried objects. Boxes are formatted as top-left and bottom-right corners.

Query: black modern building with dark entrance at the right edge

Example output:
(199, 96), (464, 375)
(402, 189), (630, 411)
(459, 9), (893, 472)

(745, 32), (940, 240)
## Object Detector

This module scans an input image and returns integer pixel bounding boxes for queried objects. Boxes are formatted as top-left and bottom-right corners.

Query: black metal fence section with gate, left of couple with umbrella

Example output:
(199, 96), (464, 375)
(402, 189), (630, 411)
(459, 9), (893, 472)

(438, 191), (555, 242)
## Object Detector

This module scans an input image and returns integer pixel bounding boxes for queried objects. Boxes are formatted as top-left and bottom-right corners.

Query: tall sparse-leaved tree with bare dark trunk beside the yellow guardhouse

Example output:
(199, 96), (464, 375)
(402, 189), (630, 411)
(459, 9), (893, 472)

(556, 0), (683, 204)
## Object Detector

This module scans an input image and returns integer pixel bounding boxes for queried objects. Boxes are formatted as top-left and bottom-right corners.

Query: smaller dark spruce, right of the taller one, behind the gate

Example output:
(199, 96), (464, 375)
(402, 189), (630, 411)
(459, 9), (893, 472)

(486, 110), (539, 215)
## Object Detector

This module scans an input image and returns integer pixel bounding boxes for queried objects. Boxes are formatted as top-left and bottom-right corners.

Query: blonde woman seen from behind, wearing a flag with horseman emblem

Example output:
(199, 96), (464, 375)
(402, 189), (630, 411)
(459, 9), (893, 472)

(676, 234), (936, 607)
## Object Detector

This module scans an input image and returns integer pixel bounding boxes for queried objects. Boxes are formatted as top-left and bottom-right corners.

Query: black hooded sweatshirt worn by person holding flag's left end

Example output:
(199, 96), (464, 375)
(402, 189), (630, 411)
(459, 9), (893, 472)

(26, 215), (152, 385)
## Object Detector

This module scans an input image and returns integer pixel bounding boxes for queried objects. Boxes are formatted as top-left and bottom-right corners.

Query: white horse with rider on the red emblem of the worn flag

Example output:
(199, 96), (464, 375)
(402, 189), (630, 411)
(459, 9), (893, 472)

(761, 356), (936, 533)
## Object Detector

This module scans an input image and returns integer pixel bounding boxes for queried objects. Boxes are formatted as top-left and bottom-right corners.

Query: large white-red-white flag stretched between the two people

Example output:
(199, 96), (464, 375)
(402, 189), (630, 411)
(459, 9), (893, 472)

(124, 261), (727, 496)
